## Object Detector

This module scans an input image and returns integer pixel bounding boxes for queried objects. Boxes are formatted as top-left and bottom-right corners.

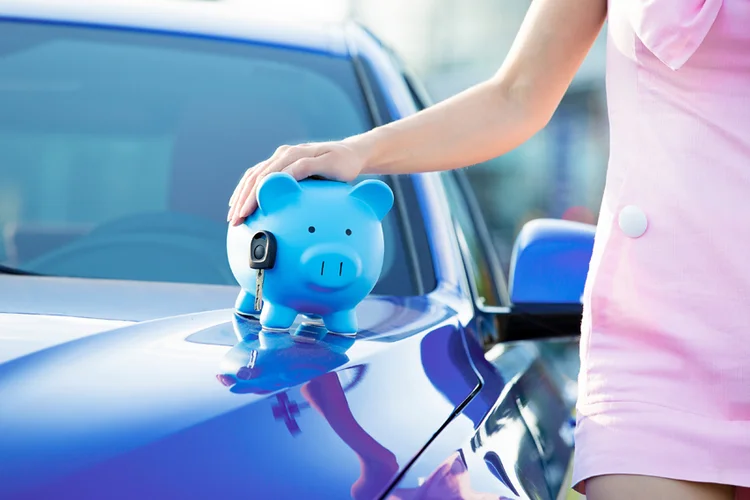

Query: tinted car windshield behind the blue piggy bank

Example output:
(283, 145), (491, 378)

(0, 21), (414, 295)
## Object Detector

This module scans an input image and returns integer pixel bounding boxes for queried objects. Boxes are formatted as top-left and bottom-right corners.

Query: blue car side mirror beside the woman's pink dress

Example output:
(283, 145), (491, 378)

(510, 219), (596, 310)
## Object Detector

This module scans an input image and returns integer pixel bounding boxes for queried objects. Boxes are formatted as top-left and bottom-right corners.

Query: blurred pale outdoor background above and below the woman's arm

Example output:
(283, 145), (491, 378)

(217, 0), (609, 266)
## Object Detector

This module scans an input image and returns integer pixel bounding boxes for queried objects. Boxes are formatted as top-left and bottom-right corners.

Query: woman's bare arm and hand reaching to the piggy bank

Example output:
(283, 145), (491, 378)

(228, 0), (607, 224)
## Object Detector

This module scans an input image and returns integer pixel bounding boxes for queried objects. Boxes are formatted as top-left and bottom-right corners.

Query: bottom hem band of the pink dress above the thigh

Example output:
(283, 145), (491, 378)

(571, 402), (750, 498)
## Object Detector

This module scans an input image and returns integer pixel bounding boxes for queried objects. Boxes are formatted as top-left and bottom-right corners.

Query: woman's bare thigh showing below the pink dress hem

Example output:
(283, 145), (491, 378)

(586, 475), (735, 500)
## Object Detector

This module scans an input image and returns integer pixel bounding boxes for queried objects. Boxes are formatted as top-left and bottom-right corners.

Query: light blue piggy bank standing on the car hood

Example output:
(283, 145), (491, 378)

(227, 172), (393, 335)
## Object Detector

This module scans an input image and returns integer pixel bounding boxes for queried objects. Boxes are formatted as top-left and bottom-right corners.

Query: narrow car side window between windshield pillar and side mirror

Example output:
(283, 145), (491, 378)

(441, 172), (505, 306)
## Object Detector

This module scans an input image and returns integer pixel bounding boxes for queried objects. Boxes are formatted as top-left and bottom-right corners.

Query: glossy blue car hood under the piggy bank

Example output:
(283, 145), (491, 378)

(0, 280), (479, 498)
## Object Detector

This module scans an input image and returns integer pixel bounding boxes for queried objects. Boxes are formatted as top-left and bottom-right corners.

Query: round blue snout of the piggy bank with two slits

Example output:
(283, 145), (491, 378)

(300, 245), (362, 290)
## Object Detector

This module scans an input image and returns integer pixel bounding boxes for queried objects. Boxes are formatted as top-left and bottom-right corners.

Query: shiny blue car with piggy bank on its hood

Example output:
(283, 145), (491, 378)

(0, 0), (593, 500)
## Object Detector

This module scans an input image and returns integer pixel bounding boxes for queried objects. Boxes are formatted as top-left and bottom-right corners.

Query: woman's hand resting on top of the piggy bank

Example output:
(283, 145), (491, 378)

(227, 140), (365, 226)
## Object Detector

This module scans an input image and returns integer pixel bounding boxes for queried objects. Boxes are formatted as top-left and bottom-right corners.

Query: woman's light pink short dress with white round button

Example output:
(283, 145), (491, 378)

(573, 0), (750, 494)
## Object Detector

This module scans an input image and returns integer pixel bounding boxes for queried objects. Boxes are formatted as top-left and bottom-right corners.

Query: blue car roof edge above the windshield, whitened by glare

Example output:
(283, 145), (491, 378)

(0, 0), (350, 56)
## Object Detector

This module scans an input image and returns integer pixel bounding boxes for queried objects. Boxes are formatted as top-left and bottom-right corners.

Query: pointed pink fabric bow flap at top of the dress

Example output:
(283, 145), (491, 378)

(624, 0), (723, 70)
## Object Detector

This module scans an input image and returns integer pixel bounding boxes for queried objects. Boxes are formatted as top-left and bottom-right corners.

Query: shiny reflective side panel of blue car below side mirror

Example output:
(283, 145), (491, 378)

(387, 339), (578, 500)
